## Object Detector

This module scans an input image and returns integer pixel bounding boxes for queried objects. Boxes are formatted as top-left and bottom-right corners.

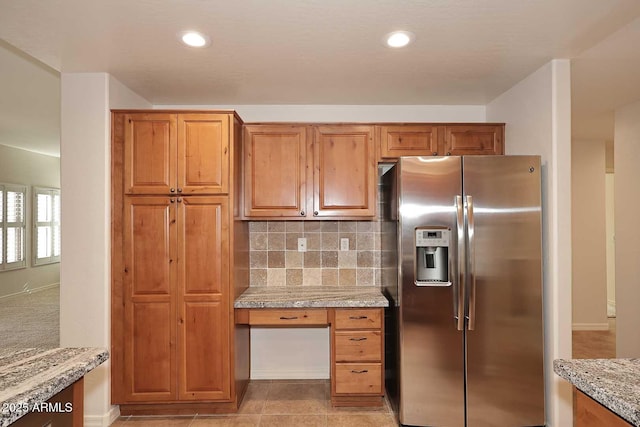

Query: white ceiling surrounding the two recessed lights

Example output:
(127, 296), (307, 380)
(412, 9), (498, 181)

(0, 0), (640, 155)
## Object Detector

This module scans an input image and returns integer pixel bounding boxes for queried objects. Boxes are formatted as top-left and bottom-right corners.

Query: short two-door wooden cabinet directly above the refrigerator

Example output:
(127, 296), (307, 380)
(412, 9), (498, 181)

(376, 123), (504, 161)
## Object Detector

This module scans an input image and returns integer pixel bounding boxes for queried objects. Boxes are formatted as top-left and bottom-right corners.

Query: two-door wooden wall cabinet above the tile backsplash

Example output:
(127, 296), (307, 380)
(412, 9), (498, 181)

(244, 124), (377, 219)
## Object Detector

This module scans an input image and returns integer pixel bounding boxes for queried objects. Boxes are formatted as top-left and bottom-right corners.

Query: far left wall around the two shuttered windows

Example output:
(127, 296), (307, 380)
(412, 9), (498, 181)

(0, 145), (60, 298)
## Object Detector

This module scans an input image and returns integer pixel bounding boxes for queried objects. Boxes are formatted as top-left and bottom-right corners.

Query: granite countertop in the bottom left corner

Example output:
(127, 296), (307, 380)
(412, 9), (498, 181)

(0, 348), (109, 427)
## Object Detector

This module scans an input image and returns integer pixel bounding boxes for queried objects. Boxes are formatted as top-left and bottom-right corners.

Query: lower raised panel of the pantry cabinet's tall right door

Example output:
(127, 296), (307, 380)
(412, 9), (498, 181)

(180, 301), (231, 400)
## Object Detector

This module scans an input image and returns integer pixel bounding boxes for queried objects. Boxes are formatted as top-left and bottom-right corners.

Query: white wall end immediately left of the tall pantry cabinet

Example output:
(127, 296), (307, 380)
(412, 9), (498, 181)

(60, 73), (151, 427)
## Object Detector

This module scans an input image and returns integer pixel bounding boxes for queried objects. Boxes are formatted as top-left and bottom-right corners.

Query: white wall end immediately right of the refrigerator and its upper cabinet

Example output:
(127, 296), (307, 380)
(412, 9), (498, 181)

(487, 60), (573, 427)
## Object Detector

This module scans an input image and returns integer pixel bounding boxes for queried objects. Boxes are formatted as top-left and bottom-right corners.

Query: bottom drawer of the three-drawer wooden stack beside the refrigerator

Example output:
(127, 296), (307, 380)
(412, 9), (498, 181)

(334, 363), (382, 395)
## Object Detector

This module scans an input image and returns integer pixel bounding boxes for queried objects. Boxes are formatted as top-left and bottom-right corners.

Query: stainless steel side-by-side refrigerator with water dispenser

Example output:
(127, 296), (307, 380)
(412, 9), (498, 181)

(381, 156), (545, 427)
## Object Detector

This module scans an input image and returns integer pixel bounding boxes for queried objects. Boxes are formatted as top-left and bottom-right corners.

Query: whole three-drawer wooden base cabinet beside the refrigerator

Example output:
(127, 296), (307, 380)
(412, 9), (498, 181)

(331, 308), (384, 406)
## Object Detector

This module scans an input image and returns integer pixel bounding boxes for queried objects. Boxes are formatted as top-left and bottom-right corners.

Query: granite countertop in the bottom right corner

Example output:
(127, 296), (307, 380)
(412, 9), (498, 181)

(553, 359), (640, 426)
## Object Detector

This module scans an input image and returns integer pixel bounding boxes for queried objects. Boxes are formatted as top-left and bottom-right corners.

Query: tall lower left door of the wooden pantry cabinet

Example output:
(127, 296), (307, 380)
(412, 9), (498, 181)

(123, 196), (177, 402)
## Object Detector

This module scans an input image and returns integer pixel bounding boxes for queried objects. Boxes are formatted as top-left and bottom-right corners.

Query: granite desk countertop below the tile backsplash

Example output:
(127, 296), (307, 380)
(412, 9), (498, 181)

(233, 286), (389, 308)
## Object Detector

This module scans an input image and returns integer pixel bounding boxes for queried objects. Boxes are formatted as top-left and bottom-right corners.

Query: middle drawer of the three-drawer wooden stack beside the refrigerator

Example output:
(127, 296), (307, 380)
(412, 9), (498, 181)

(334, 331), (382, 362)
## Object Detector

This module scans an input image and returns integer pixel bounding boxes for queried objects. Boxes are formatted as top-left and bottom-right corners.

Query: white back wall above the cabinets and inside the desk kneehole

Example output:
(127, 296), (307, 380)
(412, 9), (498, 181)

(155, 105), (485, 379)
